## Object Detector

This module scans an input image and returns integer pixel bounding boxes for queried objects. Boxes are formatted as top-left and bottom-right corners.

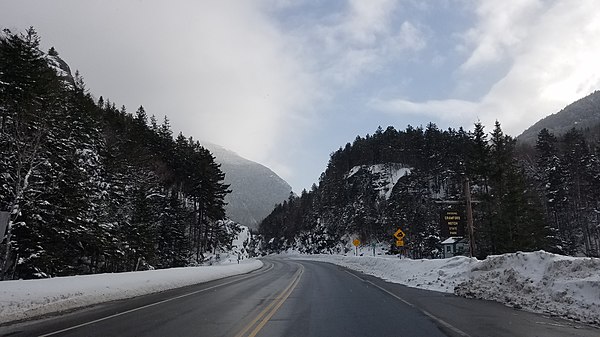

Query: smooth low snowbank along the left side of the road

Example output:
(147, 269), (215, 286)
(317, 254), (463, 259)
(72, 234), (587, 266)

(0, 260), (263, 323)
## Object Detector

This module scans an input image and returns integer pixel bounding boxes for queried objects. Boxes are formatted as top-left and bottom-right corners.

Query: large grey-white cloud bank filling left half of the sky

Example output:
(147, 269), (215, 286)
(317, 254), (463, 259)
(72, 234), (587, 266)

(0, 0), (318, 178)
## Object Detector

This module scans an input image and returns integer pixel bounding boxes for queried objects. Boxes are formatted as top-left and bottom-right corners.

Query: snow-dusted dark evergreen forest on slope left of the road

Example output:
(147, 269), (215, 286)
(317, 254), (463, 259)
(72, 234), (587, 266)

(0, 29), (235, 279)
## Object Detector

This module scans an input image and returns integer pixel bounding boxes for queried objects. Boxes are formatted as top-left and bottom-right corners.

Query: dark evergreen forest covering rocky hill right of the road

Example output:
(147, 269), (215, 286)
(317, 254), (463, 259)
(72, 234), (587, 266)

(259, 122), (600, 258)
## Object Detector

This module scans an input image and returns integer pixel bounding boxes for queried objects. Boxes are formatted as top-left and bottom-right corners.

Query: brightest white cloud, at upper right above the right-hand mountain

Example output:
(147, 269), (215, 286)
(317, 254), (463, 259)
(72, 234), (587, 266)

(373, 0), (600, 135)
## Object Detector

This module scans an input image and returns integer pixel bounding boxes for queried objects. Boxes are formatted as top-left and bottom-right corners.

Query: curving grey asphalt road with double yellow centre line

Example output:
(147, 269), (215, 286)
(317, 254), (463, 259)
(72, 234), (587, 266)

(0, 259), (600, 337)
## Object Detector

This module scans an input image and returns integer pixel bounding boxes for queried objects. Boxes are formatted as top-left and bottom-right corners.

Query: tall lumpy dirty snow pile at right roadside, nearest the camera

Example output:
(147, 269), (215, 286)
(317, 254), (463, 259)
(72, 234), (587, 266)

(454, 252), (600, 324)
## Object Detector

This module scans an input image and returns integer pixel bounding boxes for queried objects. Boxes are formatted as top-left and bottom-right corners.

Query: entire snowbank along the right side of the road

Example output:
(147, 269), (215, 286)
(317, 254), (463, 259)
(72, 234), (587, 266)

(287, 250), (600, 325)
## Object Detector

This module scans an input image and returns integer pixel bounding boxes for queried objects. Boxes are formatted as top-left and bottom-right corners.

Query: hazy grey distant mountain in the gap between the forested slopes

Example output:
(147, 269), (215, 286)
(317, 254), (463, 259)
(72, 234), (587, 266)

(202, 142), (292, 228)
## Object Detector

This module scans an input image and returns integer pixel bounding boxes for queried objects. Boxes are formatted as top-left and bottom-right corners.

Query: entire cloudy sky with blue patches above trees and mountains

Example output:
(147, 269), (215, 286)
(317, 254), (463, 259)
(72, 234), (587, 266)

(0, 0), (600, 192)
